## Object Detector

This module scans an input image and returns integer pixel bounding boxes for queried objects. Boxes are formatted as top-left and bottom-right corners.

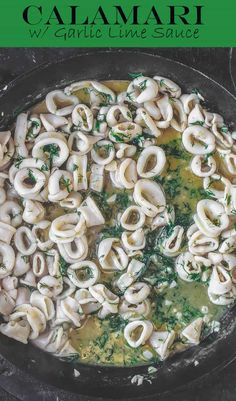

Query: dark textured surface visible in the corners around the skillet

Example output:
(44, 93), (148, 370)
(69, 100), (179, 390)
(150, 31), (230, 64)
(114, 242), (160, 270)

(0, 49), (236, 401)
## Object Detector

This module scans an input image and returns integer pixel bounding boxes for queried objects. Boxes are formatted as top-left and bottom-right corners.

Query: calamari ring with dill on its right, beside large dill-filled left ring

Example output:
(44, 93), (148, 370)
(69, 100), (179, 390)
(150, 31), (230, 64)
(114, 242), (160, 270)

(48, 169), (73, 202)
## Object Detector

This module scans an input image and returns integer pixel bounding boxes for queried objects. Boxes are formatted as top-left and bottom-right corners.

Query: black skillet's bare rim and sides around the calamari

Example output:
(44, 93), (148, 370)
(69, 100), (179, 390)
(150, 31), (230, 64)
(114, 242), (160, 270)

(0, 50), (236, 400)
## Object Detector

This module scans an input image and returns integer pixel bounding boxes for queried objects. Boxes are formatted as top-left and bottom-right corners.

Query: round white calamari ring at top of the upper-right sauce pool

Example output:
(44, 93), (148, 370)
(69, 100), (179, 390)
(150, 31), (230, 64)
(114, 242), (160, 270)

(182, 125), (215, 155)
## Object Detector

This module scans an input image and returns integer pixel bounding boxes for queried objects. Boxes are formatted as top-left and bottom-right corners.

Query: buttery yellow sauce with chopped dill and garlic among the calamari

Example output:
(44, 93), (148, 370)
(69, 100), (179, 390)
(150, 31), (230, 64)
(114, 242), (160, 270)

(60, 81), (225, 366)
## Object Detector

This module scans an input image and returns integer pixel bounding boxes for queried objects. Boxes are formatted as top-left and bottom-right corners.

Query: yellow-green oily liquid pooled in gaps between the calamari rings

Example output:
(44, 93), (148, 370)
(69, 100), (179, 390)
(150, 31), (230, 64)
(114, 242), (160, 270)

(62, 81), (225, 366)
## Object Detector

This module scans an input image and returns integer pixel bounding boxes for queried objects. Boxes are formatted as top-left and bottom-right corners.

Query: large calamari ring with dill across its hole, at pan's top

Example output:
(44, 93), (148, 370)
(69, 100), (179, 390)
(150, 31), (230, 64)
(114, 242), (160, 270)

(126, 76), (158, 104)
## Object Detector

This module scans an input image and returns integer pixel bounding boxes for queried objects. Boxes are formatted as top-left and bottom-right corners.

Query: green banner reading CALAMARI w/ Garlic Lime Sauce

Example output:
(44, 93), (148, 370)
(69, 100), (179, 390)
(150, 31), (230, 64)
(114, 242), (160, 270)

(0, 0), (236, 47)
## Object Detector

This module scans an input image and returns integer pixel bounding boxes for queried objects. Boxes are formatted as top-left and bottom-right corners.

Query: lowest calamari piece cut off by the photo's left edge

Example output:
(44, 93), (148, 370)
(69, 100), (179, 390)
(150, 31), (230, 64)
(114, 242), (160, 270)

(0, 320), (30, 344)
